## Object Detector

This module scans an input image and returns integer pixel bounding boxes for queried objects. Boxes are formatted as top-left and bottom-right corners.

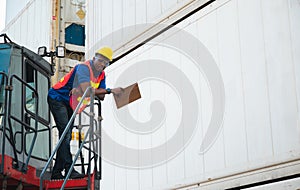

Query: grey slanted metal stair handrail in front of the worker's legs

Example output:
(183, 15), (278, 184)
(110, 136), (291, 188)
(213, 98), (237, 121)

(40, 87), (98, 190)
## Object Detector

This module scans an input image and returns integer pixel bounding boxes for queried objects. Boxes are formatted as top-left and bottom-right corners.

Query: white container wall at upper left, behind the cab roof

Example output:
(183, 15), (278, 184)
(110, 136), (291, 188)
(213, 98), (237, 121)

(3, 0), (52, 52)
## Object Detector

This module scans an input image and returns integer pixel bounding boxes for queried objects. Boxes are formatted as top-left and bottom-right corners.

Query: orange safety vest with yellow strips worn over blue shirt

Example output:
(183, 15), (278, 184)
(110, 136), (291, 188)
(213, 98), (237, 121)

(52, 61), (105, 113)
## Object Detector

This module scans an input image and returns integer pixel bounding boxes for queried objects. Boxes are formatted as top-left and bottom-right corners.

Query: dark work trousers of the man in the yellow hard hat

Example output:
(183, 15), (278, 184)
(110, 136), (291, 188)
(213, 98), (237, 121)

(48, 96), (73, 173)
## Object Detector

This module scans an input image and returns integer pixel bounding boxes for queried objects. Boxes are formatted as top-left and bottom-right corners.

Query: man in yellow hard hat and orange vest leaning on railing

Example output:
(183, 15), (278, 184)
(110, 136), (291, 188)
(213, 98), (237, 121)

(47, 47), (123, 179)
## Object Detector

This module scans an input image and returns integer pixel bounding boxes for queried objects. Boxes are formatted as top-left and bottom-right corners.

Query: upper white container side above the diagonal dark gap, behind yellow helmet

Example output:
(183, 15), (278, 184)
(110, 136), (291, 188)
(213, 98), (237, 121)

(86, 0), (198, 58)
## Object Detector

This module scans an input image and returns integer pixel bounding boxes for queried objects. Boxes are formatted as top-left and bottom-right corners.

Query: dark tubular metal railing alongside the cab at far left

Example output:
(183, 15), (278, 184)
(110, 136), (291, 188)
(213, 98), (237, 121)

(0, 72), (50, 173)
